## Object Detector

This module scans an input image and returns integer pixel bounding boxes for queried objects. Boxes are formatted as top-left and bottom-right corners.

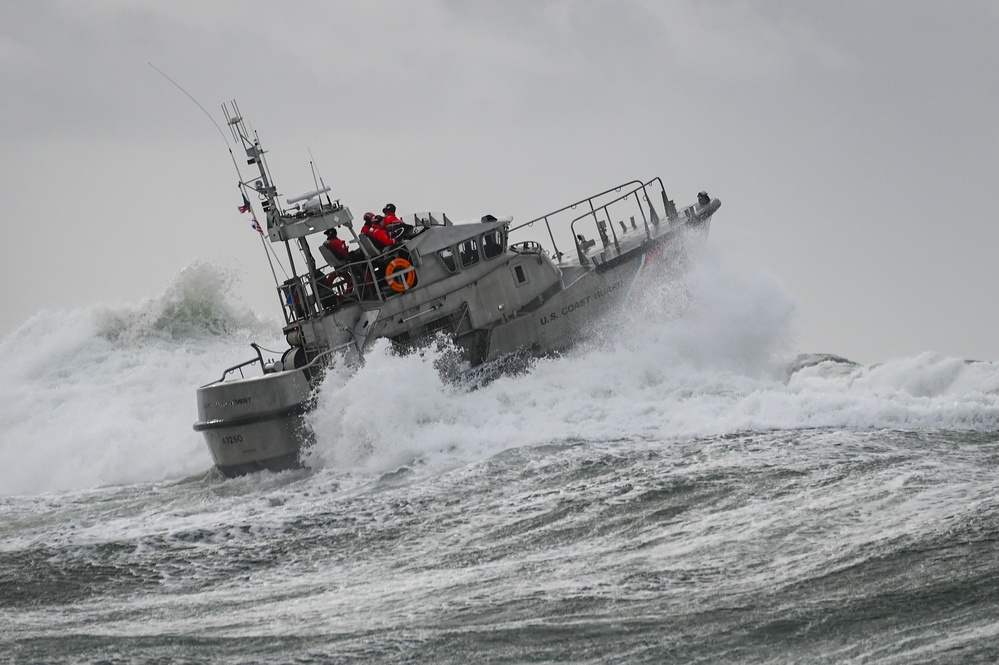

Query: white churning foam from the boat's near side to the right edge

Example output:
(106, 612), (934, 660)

(302, 241), (999, 480)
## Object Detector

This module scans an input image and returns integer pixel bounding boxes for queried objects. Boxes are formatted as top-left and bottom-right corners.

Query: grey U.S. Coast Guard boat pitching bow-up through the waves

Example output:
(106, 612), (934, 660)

(194, 104), (721, 476)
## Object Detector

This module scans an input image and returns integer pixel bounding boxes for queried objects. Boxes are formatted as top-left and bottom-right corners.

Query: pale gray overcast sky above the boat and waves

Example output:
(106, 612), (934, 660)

(0, 0), (999, 363)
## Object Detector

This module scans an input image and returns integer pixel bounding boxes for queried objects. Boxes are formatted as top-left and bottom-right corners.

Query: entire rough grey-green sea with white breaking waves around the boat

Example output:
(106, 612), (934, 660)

(0, 250), (999, 663)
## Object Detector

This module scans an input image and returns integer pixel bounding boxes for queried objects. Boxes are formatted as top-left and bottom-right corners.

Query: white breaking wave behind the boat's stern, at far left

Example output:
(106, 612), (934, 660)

(0, 264), (280, 494)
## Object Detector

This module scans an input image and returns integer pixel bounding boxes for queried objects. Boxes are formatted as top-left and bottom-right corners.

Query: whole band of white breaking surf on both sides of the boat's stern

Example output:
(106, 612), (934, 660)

(0, 252), (999, 494)
